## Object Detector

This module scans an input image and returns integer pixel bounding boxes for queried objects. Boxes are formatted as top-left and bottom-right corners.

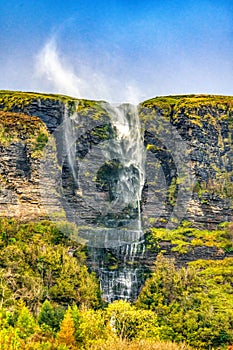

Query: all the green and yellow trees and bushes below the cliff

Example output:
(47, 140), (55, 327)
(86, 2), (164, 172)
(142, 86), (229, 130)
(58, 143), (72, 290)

(0, 219), (233, 350)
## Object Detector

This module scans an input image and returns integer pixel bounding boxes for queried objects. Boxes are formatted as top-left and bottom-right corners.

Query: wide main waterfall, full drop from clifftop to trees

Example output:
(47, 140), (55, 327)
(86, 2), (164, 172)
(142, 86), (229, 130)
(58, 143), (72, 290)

(96, 104), (146, 302)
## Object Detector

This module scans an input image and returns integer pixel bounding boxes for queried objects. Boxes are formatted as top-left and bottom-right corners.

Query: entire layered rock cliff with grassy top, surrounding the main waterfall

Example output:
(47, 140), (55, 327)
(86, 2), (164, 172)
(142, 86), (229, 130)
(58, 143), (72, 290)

(0, 91), (233, 301)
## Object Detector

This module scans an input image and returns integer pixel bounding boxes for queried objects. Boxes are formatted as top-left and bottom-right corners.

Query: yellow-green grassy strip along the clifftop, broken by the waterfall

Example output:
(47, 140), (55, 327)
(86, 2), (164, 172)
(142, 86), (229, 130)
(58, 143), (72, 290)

(0, 90), (233, 127)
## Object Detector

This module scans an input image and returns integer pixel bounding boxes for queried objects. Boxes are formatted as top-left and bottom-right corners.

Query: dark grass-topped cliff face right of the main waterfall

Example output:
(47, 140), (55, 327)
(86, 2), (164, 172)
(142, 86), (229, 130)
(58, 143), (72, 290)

(140, 95), (233, 228)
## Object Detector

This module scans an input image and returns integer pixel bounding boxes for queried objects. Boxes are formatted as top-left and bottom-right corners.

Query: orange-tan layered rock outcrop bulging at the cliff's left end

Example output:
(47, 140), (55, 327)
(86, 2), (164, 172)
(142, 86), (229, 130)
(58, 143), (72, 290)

(0, 112), (48, 220)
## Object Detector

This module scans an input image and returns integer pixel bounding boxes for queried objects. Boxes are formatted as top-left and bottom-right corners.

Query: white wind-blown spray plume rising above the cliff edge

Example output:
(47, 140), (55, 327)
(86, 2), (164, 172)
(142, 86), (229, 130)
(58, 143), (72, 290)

(35, 38), (143, 104)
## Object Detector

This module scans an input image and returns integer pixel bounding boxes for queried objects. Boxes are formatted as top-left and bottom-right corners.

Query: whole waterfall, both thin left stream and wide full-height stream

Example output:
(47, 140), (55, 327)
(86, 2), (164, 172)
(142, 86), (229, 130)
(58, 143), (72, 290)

(64, 103), (145, 302)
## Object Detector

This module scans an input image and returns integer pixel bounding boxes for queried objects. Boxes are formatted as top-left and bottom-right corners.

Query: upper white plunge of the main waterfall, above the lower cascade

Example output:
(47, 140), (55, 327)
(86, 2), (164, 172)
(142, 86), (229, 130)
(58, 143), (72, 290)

(103, 103), (146, 231)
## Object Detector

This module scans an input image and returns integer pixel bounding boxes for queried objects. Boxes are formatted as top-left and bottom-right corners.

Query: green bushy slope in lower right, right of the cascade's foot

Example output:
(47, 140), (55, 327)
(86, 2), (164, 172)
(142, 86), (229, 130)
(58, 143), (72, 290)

(137, 255), (233, 349)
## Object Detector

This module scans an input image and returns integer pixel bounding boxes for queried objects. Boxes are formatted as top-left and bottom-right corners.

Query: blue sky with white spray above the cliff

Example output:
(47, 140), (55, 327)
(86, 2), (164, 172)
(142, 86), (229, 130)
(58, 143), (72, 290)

(0, 0), (233, 103)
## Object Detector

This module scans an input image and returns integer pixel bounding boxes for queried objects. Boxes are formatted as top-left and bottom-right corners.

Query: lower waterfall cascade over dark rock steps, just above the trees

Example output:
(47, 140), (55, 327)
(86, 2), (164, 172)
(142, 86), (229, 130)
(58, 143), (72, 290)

(89, 240), (146, 303)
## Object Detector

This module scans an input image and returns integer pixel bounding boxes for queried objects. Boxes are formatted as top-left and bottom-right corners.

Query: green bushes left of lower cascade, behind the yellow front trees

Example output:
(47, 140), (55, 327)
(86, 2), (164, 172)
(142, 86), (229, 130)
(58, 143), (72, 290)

(0, 219), (101, 313)
